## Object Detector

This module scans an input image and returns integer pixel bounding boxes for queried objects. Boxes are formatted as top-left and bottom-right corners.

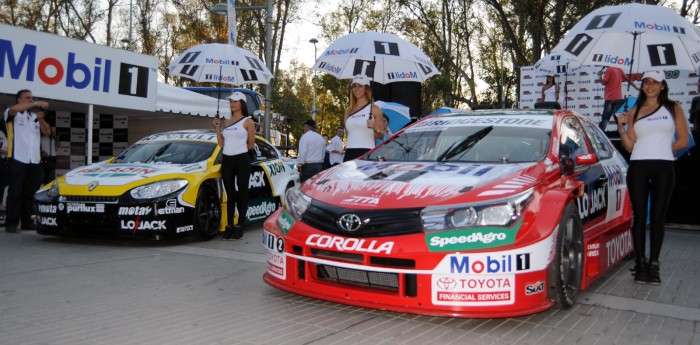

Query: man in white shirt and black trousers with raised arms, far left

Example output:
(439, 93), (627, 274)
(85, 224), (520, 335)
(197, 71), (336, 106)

(5, 90), (51, 232)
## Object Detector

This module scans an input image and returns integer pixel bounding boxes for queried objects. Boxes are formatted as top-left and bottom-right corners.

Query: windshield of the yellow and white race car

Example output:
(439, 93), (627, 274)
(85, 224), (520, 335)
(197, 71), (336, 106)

(113, 141), (216, 164)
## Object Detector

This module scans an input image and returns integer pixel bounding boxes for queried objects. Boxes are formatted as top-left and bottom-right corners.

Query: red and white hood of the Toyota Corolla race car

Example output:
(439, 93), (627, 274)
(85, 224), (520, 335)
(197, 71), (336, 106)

(302, 160), (543, 208)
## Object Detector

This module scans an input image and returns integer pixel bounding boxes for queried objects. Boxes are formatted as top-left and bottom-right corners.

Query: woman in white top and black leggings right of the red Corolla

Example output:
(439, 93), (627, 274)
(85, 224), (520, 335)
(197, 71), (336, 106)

(617, 71), (689, 285)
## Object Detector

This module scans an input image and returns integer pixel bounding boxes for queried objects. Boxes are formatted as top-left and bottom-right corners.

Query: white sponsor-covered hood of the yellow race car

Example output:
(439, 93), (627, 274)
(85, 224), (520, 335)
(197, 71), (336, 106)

(64, 162), (206, 186)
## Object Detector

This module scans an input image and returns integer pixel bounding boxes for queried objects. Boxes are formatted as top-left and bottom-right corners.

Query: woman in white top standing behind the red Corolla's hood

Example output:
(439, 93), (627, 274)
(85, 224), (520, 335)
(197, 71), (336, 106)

(343, 75), (382, 162)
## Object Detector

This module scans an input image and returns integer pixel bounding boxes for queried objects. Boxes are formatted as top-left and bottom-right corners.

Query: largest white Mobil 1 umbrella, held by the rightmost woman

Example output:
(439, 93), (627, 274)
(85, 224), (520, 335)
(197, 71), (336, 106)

(552, 3), (700, 73)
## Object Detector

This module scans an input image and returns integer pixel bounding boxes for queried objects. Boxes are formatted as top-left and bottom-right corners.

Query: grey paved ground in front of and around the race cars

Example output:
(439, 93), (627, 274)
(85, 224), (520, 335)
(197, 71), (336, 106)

(0, 223), (700, 345)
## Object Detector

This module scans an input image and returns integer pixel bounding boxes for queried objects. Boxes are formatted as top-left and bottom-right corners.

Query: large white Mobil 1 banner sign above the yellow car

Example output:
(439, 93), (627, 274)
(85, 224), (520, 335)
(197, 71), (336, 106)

(0, 24), (158, 111)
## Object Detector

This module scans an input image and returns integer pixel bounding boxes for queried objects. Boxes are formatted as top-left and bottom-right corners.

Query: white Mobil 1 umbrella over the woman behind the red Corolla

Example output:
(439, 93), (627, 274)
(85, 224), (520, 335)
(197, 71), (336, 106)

(313, 31), (440, 84)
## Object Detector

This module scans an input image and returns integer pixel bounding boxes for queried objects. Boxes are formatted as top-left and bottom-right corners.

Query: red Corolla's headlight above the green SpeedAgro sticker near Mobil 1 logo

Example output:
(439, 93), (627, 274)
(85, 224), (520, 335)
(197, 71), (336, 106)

(421, 188), (533, 233)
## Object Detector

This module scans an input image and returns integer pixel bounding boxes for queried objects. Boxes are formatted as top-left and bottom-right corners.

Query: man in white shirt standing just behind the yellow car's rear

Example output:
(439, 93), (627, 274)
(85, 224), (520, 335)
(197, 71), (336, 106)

(297, 120), (326, 183)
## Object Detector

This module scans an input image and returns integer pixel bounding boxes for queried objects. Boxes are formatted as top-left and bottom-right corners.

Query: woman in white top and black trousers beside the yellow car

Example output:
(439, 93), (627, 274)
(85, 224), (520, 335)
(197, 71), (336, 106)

(214, 92), (255, 240)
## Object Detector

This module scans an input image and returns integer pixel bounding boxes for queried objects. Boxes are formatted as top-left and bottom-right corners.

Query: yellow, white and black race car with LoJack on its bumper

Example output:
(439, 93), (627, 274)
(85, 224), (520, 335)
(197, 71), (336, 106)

(34, 130), (299, 240)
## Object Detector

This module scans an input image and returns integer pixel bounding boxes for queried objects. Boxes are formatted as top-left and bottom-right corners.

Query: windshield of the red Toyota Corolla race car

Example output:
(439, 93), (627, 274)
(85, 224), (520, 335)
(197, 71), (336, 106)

(366, 116), (552, 163)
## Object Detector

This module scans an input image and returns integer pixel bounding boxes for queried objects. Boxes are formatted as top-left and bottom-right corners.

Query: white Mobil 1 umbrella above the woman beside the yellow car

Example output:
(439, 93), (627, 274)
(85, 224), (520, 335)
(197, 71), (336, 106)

(168, 43), (272, 85)
